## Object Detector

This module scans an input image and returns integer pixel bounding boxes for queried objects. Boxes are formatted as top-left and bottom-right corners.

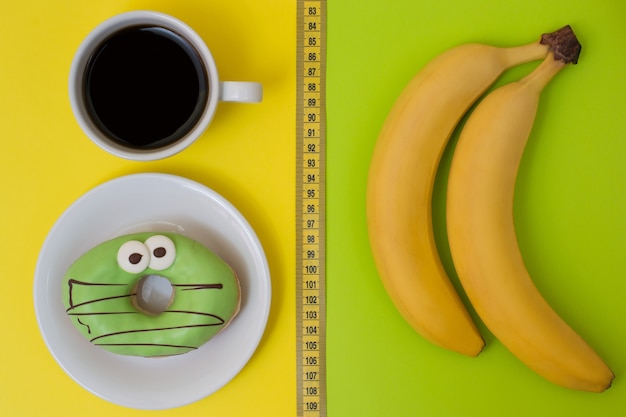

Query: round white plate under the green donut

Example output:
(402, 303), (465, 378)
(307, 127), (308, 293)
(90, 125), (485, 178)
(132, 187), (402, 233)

(34, 174), (271, 409)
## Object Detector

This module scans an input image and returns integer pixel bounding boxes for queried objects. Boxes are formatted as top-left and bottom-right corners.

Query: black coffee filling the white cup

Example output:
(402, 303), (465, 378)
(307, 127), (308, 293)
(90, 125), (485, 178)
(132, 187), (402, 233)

(84, 27), (208, 149)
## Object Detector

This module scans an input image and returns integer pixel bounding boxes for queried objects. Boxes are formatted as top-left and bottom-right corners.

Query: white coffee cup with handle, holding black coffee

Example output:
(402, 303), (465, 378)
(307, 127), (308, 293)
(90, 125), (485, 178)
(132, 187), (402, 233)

(69, 11), (263, 161)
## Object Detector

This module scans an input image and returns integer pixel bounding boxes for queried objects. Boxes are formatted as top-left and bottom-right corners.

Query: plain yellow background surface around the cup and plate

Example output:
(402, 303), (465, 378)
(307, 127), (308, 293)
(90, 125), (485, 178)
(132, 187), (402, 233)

(0, 0), (296, 417)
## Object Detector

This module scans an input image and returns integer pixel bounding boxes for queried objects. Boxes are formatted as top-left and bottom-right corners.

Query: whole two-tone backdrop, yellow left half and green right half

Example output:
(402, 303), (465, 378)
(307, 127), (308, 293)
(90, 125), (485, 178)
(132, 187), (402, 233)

(0, 0), (626, 417)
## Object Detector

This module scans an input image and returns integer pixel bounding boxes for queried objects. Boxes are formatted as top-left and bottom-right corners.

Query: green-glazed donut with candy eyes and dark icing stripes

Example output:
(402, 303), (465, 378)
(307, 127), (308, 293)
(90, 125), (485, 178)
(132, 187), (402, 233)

(62, 232), (241, 357)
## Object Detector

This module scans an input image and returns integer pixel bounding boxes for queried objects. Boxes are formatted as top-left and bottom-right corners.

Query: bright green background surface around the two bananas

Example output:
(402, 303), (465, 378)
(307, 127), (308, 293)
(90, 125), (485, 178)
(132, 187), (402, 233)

(327, 0), (626, 417)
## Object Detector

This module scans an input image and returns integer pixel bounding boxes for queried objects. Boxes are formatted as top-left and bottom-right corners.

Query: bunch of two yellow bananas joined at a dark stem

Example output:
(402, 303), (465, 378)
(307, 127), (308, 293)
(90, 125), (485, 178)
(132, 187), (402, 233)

(367, 26), (613, 392)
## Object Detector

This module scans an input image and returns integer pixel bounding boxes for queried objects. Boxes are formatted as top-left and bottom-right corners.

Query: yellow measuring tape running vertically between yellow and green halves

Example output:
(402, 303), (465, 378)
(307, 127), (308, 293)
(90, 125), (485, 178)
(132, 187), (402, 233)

(296, 0), (326, 417)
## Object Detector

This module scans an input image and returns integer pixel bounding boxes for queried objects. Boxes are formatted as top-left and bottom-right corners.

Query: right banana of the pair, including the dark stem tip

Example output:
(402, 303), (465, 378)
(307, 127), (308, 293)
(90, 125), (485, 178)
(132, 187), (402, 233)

(446, 27), (614, 392)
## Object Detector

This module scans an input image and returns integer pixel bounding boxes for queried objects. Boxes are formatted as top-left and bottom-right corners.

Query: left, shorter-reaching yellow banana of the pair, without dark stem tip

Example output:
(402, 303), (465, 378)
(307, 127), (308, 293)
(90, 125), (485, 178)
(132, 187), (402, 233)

(366, 30), (560, 356)
